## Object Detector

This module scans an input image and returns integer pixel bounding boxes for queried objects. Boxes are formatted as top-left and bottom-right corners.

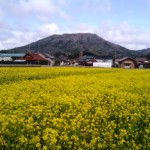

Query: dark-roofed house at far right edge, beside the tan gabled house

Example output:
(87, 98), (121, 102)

(136, 57), (150, 68)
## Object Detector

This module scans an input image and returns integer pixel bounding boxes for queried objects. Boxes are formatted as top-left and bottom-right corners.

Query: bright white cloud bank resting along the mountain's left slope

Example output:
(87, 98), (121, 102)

(0, 23), (61, 49)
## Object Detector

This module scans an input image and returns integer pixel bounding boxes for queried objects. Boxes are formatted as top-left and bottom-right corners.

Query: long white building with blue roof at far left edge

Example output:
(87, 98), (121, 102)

(0, 53), (25, 61)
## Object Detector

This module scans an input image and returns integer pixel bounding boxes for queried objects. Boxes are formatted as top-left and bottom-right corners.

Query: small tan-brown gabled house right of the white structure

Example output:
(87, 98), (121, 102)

(118, 57), (137, 69)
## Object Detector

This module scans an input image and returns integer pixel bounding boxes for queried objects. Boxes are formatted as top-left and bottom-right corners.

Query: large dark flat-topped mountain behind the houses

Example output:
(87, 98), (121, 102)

(8, 33), (141, 58)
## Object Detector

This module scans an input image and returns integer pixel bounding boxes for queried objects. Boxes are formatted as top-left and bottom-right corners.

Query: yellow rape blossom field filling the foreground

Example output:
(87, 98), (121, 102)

(0, 67), (150, 150)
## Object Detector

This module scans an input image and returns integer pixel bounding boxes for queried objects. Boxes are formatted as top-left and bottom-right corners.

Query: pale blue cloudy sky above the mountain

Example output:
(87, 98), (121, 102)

(0, 0), (150, 50)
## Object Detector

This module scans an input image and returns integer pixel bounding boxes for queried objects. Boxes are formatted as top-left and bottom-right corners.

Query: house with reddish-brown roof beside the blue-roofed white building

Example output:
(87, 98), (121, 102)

(18, 53), (51, 65)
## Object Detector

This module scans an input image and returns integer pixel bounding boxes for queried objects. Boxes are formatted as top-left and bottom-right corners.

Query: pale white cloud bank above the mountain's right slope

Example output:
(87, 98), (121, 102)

(95, 22), (150, 50)
